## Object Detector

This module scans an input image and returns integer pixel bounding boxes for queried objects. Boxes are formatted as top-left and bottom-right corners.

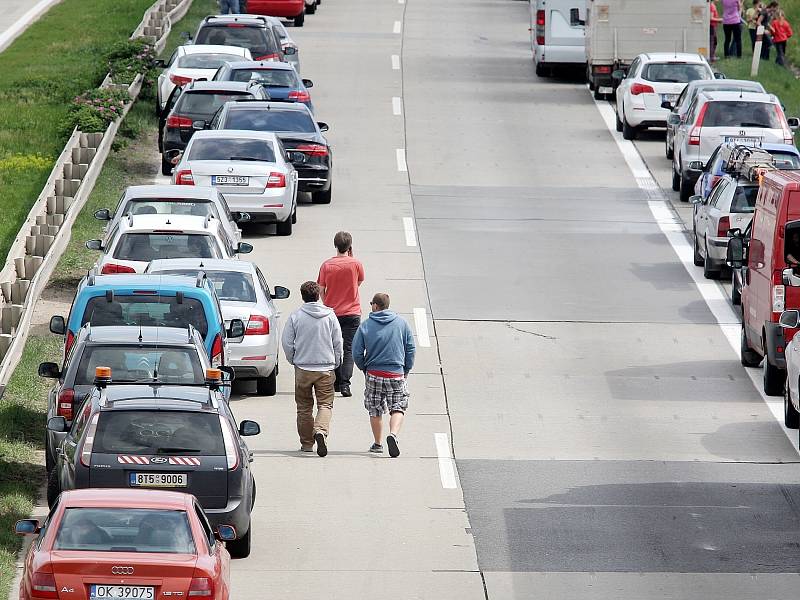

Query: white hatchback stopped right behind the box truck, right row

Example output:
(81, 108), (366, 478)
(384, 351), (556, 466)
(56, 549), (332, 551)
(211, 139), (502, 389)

(612, 52), (714, 140)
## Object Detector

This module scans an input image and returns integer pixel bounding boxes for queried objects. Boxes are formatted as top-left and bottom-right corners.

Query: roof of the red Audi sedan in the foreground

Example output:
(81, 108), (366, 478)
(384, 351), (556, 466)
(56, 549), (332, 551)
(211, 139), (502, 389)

(60, 488), (194, 510)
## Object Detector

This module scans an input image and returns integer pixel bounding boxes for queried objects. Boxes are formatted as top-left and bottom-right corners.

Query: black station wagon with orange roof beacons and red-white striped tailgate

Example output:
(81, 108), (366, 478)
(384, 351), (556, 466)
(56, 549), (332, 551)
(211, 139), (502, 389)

(47, 367), (261, 558)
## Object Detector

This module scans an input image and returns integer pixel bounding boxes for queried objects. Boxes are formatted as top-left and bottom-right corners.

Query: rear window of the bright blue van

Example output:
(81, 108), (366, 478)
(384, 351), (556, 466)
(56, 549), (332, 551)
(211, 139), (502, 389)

(81, 294), (208, 338)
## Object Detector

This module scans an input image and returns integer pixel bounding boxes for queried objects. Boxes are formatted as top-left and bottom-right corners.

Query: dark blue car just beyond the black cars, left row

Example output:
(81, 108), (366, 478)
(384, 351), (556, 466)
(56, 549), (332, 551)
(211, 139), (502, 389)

(213, 60), (314, 113)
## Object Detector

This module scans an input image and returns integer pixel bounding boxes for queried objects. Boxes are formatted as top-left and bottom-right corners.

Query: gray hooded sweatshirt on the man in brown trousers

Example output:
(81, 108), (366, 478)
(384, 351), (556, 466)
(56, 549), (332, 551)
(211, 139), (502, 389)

(281, 302), (342, 371)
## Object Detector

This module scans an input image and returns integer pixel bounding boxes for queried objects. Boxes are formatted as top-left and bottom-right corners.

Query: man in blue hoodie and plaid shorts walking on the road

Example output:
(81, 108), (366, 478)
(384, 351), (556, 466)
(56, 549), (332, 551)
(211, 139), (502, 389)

(353, 294), (416, 458)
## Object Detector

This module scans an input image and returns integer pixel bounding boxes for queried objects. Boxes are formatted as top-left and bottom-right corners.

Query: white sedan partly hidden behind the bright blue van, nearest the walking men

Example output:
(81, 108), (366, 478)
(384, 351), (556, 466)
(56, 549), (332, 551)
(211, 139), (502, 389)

(147, 259), (289, 396)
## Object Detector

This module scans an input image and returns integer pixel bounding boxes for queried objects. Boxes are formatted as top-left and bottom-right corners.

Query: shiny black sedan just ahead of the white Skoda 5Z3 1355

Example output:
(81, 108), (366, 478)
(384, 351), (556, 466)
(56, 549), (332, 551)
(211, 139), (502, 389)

(211, 101), (333, 204)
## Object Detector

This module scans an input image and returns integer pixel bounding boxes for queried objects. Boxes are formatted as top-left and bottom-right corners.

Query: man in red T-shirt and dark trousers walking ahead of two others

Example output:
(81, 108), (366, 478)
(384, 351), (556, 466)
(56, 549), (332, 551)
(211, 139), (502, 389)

(317, 231), (364, 397)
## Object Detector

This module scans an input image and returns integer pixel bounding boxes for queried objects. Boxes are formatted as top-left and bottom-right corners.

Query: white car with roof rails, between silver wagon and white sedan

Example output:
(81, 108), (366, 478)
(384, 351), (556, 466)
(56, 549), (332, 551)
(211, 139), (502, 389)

(86, 215), (253, 275)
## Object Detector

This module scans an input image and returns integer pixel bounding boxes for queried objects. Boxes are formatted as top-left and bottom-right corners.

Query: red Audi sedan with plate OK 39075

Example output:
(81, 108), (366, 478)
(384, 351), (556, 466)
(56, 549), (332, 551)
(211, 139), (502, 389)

(15, 489), (235, 600)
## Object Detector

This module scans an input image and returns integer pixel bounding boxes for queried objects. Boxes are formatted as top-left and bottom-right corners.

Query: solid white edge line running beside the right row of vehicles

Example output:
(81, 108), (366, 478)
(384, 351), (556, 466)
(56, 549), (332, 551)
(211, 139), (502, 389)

(594, 100), (800, 454)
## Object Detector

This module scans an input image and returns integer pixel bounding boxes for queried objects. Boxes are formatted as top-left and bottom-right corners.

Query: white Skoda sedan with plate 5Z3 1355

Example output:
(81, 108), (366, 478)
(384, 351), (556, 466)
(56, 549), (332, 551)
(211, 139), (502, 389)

(172, 129), (298, 235)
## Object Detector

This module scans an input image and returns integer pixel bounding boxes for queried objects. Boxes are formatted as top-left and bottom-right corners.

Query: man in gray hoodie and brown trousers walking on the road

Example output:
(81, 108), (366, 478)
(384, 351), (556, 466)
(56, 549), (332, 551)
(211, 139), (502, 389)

(281, 281), (343, 456)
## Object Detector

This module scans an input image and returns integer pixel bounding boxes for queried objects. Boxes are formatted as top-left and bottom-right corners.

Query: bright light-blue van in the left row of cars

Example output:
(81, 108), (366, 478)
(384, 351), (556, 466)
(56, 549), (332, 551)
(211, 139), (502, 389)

(50, 271), (244, 367)
